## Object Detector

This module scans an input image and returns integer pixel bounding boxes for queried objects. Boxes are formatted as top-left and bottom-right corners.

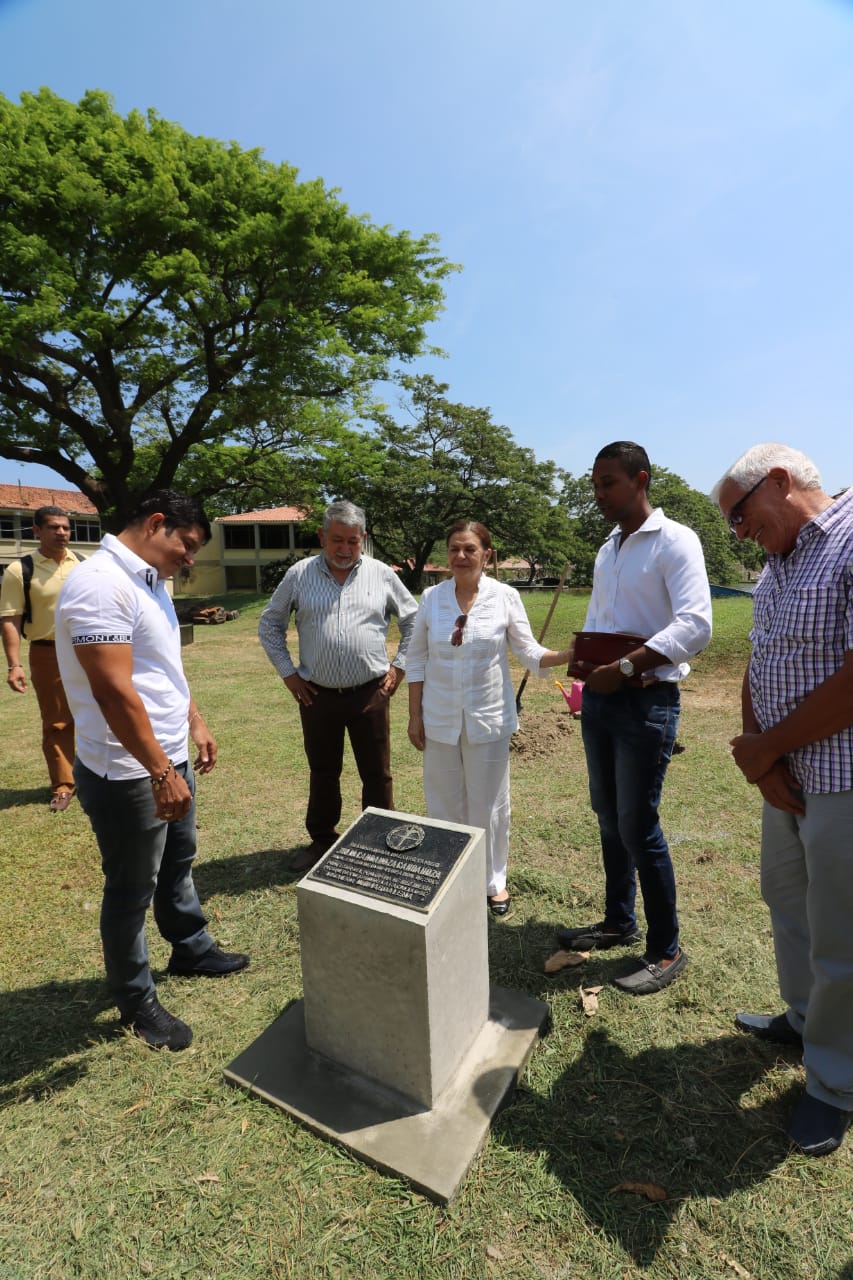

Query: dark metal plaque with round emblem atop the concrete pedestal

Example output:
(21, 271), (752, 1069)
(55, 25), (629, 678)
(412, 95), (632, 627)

(309, 813), (471, 911)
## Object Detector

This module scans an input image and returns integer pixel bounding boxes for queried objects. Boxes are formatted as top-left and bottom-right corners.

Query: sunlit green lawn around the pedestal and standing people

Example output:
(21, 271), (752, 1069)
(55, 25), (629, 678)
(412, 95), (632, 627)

(0, 595), (853, 1280)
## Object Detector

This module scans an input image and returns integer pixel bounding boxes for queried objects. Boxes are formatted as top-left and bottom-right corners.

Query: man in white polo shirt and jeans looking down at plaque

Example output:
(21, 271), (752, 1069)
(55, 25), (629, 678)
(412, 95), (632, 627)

(56, 490), (248, 1050)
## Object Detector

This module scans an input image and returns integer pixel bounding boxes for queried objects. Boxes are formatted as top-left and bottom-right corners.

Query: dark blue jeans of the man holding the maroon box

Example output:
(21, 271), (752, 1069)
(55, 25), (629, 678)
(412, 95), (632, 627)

(580, 684), (681, 961)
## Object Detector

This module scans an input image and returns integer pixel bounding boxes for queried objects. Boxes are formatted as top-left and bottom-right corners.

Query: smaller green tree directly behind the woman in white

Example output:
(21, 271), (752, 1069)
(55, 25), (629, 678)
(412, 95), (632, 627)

(318, 375), (556, 591)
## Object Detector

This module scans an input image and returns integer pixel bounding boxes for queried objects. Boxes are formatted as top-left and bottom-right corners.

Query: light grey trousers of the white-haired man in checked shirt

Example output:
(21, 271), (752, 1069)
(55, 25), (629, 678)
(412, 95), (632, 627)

(761, 791), (853, 1111)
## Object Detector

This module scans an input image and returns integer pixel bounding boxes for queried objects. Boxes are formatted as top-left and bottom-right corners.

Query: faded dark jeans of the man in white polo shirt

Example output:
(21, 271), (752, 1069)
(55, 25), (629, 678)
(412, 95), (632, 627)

(74, 759), (213, 1016)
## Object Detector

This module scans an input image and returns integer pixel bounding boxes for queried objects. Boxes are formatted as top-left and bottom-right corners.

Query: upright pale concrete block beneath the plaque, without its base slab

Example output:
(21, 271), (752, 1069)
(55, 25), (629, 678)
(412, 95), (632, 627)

(297, 810), (489, 1107)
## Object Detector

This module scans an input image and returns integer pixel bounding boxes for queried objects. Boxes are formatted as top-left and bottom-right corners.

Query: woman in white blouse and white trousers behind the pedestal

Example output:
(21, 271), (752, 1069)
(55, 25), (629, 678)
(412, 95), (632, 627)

(406, 520), (570, 915)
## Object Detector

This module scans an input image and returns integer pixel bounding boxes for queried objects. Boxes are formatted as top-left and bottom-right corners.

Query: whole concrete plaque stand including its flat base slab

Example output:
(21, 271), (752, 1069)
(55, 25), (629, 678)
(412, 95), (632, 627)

(225, 810), (548, 1202)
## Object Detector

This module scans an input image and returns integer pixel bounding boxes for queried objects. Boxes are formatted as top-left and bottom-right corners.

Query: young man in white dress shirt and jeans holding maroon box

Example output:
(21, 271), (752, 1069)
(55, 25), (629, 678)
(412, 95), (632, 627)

(557, 440), (711, 996)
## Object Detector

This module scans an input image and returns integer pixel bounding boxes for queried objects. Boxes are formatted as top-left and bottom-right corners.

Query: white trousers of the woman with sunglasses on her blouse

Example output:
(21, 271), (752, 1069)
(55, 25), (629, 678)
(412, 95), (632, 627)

(424, 730), (510, 897)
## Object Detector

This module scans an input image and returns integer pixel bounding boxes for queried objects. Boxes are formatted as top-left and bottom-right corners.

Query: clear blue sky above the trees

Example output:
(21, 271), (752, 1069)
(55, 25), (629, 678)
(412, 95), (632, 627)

(0, 0), (853, 498)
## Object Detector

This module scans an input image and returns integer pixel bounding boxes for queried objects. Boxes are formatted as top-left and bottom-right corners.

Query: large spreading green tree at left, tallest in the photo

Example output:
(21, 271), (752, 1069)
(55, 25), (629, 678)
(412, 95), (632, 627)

(0, 90), (452, 518)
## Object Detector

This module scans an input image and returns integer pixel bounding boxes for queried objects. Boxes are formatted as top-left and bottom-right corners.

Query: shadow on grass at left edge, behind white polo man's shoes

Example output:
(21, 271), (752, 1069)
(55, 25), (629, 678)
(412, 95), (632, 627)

(0, 978), (113, 1106)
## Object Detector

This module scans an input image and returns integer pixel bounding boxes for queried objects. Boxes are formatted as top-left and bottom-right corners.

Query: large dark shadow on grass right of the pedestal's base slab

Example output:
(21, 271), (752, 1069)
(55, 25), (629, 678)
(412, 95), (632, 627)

(479, 1028), (790, 1266)
